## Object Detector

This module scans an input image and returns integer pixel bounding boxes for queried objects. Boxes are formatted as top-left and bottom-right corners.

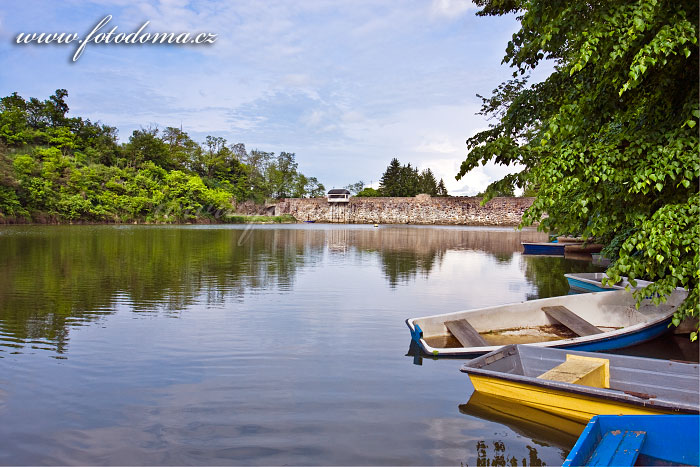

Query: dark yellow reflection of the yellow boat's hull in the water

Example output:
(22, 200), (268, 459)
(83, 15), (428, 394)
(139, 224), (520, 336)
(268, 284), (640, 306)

(459, 391), (585, 450)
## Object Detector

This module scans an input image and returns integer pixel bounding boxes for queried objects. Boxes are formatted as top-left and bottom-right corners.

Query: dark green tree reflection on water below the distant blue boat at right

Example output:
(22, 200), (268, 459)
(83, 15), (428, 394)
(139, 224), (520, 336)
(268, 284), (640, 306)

(521, 255), (601, 300)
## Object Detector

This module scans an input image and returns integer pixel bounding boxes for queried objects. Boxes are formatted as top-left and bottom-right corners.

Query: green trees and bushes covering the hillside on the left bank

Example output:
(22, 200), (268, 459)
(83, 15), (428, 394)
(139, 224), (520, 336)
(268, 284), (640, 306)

(0, 89), (325, 222)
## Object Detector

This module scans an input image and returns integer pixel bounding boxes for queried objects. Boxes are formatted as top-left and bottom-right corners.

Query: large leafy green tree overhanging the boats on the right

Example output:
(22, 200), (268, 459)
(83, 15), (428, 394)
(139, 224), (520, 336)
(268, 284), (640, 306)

(457, 0), (700, 339)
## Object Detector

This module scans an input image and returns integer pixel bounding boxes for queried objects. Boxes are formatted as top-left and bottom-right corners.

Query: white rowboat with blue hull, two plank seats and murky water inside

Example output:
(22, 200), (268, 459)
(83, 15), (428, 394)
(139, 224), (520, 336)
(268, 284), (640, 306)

(406, 290), (687, 357)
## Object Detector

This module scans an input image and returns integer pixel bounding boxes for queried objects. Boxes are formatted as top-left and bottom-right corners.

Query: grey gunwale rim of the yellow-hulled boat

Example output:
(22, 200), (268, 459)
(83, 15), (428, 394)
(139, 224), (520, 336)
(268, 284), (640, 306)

(459, 344), (700, 414)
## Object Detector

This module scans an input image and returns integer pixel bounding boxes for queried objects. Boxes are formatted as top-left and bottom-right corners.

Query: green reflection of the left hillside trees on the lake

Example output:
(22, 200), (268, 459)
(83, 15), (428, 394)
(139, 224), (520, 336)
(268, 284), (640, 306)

(0, 227), (323, 352)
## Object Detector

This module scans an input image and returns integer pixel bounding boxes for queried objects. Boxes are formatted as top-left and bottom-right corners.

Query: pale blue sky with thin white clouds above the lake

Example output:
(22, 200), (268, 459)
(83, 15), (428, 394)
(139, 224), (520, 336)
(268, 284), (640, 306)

(0, 0), (540, 195)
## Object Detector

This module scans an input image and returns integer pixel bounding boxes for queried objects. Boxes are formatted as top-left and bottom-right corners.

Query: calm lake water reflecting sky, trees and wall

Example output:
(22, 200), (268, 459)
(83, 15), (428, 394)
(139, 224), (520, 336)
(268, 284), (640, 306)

(0, 225), (692, 465)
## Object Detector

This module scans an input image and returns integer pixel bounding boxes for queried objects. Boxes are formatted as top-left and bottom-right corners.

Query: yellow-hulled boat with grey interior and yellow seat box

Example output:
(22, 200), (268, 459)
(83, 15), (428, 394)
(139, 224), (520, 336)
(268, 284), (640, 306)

(461, 345), (700, 423)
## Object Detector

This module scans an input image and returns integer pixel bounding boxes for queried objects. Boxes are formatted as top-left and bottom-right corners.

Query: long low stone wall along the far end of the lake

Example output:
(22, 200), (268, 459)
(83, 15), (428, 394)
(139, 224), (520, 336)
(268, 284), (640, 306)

(274, 195), (533, 225)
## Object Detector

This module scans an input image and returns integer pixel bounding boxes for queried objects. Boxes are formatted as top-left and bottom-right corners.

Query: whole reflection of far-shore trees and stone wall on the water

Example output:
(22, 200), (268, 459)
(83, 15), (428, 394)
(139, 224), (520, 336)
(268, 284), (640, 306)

(0, 226), (568, 352)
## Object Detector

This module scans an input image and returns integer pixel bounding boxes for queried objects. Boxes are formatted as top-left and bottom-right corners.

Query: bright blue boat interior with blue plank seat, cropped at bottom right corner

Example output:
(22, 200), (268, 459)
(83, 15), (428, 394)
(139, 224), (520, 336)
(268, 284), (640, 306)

(562, 415), (700, 467)
